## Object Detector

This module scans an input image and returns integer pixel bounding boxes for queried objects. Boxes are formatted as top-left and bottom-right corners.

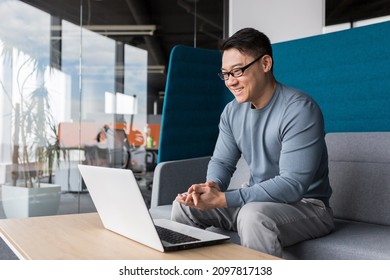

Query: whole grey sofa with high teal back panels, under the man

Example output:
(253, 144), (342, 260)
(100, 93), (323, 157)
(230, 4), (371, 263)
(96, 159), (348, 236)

(150, 22), (390, 259)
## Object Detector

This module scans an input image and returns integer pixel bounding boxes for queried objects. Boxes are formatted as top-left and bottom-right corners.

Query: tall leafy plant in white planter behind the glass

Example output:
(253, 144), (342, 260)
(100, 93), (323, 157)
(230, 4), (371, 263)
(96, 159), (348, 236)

(1, 46), (61, 218)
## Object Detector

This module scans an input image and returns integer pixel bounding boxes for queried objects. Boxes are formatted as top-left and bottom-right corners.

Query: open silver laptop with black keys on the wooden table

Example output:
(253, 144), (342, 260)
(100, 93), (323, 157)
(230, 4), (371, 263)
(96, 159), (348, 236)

(78, 165), (229, 252)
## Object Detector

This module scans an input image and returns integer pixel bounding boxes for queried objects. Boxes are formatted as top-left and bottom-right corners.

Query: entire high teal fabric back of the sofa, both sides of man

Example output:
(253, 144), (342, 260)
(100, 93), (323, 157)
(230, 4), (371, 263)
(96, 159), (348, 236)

(159, 22), (390, 162)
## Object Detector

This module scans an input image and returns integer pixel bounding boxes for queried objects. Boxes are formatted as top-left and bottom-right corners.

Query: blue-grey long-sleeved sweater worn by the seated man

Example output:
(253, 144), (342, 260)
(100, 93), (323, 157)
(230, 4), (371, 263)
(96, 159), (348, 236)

(207, 84), (332, 207)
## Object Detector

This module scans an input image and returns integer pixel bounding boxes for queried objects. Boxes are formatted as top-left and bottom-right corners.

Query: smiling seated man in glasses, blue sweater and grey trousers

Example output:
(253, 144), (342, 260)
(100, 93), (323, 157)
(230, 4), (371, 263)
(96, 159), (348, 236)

(172, 28), (333, 257)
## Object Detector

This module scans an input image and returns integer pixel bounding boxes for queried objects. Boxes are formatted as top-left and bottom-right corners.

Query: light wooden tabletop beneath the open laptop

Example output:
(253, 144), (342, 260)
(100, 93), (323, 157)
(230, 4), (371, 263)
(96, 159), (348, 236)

(0, 213), (277, 260)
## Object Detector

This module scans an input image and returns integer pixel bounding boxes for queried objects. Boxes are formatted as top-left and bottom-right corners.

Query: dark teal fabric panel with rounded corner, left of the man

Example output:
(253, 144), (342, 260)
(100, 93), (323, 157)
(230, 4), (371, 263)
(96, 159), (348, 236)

(158, 46), (233, 162)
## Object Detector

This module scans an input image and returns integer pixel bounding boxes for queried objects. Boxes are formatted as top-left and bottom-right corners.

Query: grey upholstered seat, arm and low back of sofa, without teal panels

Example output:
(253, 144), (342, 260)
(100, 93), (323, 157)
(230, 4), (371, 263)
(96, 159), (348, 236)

(150, 132), (390, 260)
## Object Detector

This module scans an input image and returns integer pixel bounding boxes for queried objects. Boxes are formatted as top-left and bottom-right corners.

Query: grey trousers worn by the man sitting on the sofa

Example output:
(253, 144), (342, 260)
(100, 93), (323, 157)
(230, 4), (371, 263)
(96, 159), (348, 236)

(171, 199), (334, 257)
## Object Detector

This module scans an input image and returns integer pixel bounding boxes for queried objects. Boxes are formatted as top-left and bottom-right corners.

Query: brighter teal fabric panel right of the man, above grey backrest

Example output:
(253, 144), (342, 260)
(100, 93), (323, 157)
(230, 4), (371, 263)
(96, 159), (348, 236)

(273, 22), (390, 132)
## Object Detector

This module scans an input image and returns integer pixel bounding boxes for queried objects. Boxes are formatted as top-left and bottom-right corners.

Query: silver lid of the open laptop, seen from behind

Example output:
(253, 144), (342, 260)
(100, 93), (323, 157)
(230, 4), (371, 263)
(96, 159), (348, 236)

(79, 165), (164, 252)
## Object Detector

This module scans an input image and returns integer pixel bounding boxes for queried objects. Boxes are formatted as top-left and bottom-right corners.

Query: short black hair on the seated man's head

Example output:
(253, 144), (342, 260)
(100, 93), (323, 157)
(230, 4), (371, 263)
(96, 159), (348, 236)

(220, 27), (272, 58)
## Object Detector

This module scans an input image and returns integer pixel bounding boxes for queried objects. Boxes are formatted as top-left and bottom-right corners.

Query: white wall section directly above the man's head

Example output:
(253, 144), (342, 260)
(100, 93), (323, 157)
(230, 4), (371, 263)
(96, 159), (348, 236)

(229, 0), (325, 43)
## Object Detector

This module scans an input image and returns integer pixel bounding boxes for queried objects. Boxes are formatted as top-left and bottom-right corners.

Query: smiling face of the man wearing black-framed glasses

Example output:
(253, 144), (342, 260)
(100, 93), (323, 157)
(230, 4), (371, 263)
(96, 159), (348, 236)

(221, 49), (266, 108)
